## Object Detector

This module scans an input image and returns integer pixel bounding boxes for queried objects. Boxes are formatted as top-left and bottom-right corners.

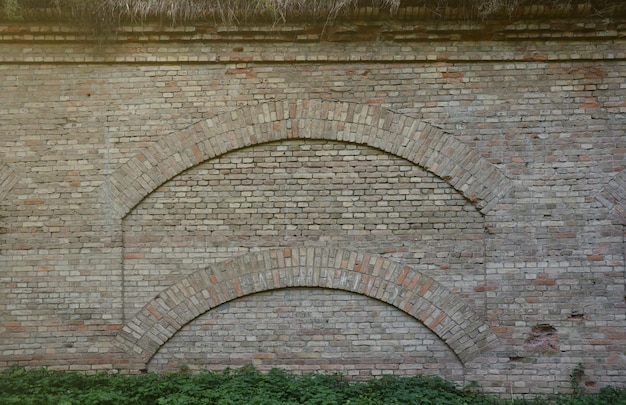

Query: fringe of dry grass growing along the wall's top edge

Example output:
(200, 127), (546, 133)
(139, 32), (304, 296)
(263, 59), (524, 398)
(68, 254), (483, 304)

(0, 0), (626, 42)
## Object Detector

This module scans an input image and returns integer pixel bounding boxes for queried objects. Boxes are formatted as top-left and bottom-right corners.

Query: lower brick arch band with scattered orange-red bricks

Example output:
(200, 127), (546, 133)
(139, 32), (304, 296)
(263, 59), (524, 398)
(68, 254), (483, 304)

(116, 248), (498, 364)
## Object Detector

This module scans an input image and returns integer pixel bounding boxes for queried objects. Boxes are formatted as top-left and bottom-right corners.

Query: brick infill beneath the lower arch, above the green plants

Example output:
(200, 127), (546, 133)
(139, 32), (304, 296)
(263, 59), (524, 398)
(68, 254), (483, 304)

(148, 289), (464, 384)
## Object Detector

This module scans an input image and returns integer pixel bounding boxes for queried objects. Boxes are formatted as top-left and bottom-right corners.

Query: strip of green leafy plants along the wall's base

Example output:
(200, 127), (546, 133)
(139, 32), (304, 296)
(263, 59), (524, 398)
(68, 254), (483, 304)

(0, 366), (626, 405)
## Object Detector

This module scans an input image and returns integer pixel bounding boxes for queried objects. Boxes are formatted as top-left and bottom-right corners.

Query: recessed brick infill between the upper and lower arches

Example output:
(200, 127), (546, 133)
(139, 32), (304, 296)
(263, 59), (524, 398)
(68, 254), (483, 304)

(123, 140), (485, 317)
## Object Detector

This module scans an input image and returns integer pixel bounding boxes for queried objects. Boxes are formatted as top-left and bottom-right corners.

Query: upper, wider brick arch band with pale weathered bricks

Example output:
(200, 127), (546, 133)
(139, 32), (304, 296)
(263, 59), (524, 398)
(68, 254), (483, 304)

(104, 100), (511, 218)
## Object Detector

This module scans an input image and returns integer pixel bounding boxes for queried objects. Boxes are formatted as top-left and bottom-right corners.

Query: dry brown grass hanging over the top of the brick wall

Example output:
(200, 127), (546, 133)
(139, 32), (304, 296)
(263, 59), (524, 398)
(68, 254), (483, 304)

(0, 0), (624, 33)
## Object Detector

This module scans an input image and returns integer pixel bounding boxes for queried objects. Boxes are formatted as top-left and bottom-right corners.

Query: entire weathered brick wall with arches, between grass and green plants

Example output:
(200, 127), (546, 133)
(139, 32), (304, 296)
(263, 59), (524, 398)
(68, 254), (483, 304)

(0, 6), (626, 395)
